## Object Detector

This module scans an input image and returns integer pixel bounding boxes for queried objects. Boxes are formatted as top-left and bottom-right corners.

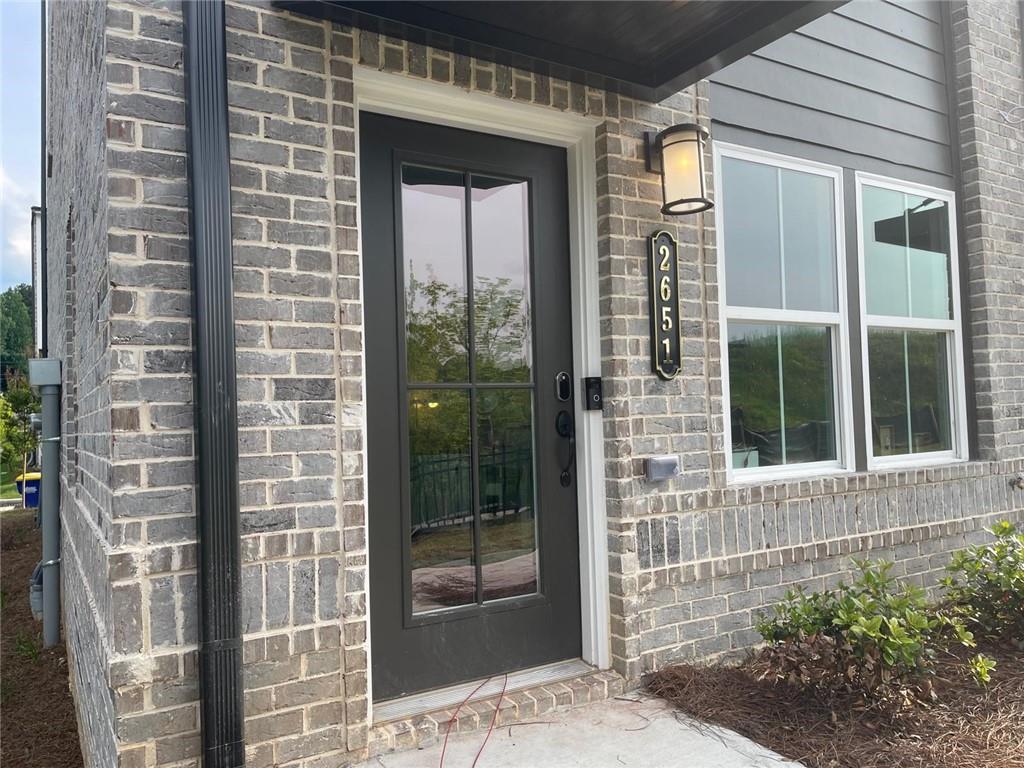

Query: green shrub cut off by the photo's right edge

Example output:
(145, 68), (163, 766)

(942, 521), (1024, 645)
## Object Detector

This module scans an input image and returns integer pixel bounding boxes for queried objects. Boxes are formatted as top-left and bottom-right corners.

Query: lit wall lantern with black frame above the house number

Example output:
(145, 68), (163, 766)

(644, 123), (715, 216)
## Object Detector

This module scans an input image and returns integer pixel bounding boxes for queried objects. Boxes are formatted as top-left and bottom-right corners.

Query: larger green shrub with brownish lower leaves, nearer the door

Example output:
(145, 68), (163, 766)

(757, 560), (992, 706)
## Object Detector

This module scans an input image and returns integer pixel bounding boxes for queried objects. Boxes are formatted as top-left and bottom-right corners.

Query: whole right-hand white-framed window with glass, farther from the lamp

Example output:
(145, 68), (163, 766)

(856, 173), (967, 469)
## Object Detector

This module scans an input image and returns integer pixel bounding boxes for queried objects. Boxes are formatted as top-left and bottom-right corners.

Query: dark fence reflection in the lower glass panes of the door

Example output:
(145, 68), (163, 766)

(410, 447), (534, 532)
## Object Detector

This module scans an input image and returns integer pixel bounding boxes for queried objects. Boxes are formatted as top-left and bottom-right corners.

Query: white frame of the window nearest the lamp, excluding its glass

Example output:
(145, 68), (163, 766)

(713, 141), (856, 484)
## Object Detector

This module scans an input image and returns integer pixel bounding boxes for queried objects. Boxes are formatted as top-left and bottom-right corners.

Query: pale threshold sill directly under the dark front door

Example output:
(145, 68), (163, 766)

(374, 658), (597, 725)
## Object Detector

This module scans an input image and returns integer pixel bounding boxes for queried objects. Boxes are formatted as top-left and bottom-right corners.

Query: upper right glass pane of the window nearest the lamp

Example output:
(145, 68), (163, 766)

(778, 170), (839, 312)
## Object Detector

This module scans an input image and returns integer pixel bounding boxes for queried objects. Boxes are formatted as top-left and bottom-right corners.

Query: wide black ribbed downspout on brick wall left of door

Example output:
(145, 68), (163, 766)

(181, 0), (245, 768)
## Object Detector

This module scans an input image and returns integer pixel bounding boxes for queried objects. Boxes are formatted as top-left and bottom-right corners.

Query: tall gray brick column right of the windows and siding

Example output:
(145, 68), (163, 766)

(952, 0), (1024, 459)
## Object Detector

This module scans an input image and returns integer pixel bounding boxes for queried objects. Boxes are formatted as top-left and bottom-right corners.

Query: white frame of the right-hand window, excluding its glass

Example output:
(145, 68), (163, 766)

(855, 171), (968, 470)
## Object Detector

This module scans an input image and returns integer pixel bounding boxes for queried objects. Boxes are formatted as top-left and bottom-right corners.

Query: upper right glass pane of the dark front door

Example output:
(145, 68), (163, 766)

(472, 179), (534, 382)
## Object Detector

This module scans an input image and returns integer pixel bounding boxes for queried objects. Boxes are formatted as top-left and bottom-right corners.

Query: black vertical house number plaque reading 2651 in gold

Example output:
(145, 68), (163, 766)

(647, 231), (682, 380)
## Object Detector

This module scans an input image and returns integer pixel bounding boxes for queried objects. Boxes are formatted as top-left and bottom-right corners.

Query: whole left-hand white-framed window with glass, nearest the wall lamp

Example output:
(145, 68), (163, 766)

(714, 143), (854, 481)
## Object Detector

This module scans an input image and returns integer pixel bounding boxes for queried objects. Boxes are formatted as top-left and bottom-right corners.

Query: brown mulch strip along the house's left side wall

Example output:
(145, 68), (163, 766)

(0, 510), (82, 768)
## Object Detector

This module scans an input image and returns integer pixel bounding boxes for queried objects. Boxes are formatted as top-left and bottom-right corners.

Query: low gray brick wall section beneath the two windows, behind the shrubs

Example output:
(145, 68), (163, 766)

(630, 468), (1024, 677)
